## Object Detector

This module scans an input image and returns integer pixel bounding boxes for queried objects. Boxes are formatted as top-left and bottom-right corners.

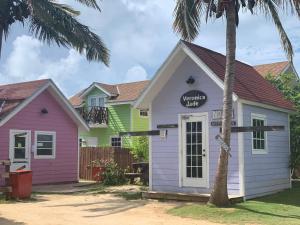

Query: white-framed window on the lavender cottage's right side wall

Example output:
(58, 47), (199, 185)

(251, 114), (267, 154)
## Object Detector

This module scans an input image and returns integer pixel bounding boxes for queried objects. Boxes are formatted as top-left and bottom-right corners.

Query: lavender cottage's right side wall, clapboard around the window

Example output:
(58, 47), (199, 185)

(243, 105), (290, 198)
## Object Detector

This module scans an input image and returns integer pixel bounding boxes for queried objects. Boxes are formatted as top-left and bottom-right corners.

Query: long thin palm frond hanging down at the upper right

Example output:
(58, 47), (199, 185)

(264, 0), (294, 62)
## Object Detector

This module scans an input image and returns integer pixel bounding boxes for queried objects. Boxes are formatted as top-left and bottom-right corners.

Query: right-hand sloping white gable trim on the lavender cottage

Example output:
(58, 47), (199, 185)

(182, 43), (238, 101)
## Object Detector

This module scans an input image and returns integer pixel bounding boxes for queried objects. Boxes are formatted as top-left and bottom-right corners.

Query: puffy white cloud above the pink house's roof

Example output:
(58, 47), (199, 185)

(0, 35), (82, 93)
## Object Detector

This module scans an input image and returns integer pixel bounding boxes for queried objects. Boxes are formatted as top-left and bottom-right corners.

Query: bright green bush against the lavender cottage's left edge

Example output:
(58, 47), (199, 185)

(131, 136), (149, 162)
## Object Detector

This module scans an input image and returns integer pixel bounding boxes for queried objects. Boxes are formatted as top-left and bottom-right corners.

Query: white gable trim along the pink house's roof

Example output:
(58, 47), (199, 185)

(0, 80), (89, 131)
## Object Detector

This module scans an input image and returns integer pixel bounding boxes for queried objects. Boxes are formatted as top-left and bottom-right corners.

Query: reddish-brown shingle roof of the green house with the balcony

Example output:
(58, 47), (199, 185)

(69, 80), (149, 107)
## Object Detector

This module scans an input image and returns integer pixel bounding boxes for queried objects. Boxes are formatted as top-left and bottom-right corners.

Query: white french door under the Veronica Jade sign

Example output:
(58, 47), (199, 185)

(181, 113), (208, 187)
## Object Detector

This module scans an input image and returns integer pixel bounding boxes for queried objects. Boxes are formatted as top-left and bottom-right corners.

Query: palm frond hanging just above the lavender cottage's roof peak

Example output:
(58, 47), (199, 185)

(173, 0), (202, 41)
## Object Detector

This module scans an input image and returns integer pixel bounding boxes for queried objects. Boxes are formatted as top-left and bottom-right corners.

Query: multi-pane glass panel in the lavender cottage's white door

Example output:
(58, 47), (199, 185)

(185, 122), (203, 178)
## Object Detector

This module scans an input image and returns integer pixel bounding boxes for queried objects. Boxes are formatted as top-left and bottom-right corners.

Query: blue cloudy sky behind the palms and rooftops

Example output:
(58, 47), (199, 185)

(0, 0), (300, 96)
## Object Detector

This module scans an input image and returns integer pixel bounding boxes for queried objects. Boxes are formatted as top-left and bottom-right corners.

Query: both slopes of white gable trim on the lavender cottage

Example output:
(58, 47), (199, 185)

(134, 41), (238, 108)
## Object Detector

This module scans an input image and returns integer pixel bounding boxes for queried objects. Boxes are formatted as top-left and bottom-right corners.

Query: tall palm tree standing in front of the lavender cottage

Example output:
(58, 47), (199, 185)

(173, 0), (300, 206)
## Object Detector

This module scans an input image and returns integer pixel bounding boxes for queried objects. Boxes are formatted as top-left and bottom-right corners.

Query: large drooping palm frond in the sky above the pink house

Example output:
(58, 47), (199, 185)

(29, 0), (109, 65)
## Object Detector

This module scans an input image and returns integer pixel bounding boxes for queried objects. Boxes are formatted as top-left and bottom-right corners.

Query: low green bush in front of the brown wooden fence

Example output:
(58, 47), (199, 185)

(103, 161), (128, 185)
